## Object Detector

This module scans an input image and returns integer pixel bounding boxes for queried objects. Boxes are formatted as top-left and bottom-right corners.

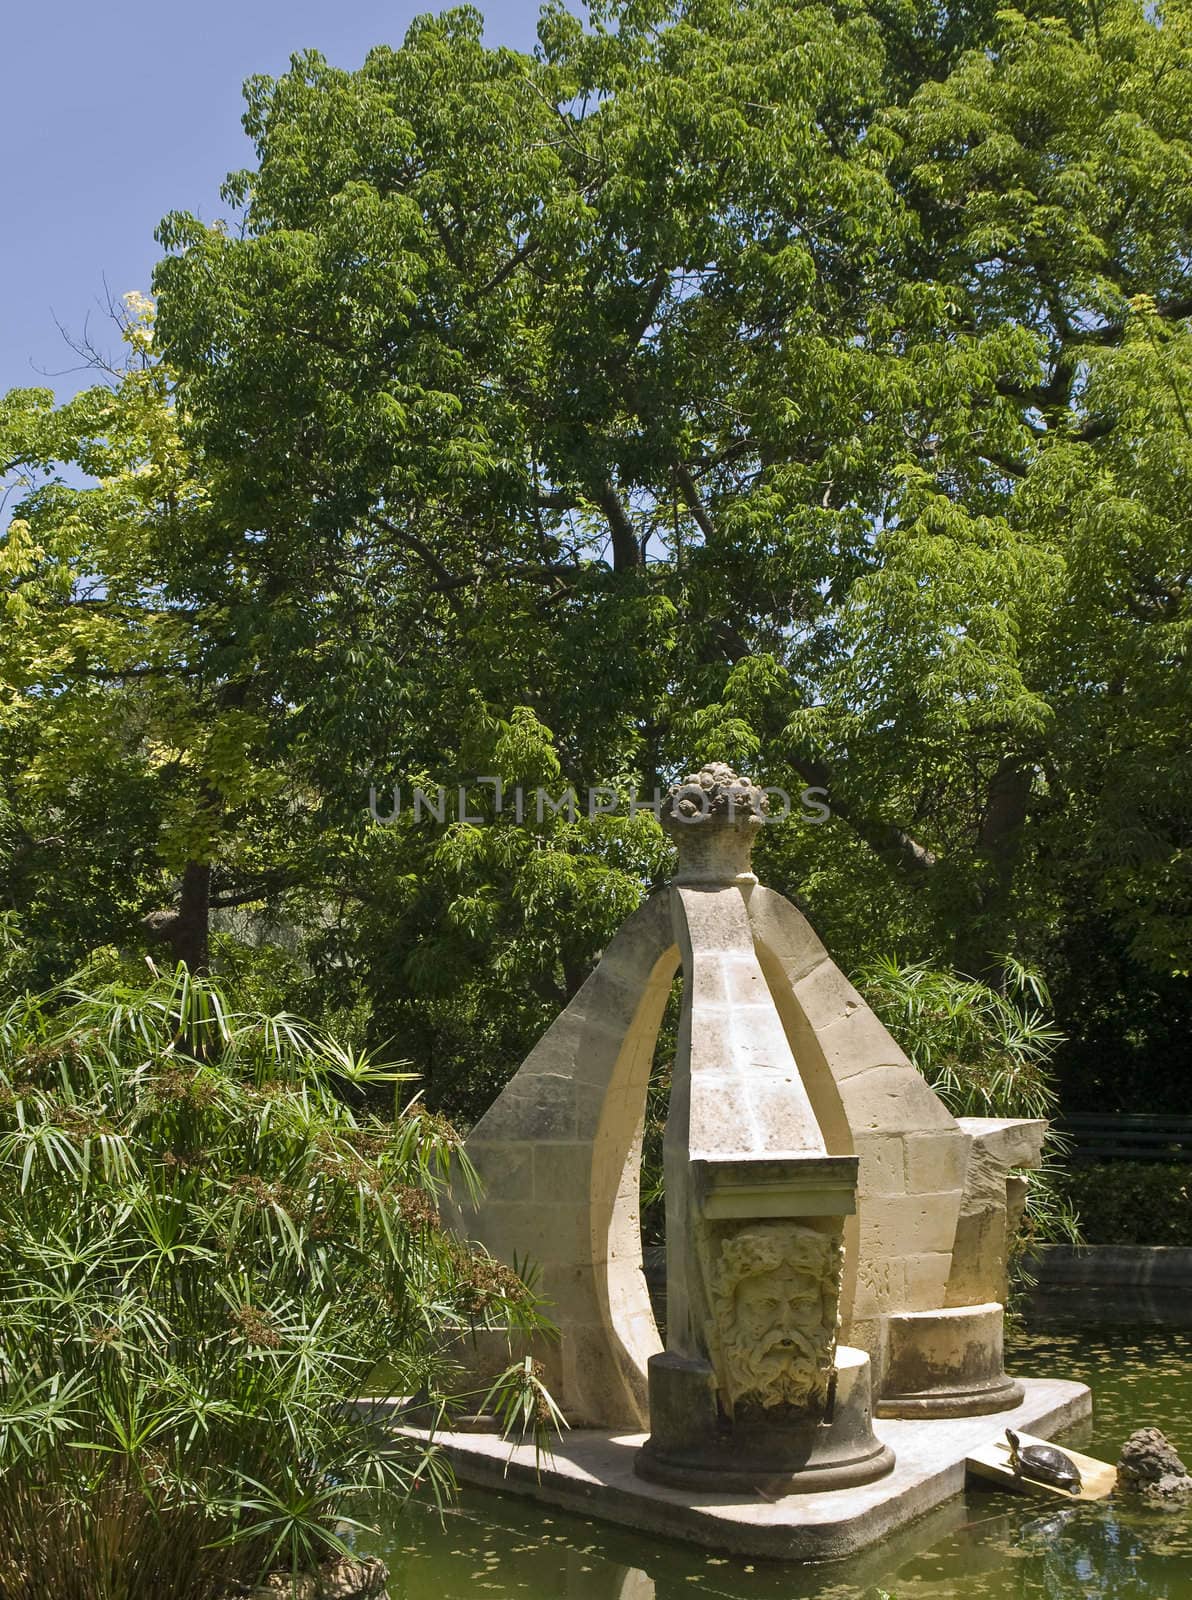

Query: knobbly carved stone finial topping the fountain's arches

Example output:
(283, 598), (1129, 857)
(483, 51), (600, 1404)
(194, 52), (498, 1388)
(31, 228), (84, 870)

(659, 762), (768, 883)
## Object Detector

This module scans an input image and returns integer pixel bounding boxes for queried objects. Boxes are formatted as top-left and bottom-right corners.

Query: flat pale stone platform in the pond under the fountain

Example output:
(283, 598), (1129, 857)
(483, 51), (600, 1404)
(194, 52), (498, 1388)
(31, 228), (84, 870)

(410, 1378), (1093, 1562)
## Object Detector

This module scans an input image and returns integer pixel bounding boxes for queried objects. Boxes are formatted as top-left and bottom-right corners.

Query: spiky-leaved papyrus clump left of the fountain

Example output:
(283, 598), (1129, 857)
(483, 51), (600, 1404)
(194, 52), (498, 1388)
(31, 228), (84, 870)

(0, 968), (538, 1600)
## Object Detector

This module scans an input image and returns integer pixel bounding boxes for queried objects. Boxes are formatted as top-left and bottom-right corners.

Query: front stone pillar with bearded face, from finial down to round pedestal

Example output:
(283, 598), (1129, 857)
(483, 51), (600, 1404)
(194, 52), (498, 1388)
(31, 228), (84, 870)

(637, 765), (893, 1490)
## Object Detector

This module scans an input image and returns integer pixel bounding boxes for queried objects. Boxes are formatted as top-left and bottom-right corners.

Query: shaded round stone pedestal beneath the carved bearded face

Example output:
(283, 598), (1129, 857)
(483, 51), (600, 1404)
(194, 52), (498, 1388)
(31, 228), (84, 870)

(634, 1344), (894, 1496)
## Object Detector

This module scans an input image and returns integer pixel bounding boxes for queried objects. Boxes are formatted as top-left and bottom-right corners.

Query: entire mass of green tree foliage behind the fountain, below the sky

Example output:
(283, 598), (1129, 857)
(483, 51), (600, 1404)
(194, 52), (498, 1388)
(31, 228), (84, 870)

(0, 0), (1192, 1114)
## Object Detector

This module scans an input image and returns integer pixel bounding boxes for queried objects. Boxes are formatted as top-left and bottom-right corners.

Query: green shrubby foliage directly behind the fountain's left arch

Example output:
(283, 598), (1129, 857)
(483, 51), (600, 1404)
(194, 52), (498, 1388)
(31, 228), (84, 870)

(299, 707), (670, 1120)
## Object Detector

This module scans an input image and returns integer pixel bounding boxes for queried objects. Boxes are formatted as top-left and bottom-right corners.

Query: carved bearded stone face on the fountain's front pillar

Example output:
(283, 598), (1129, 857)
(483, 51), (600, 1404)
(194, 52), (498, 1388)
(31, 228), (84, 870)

(715, 1222), (842, 1408)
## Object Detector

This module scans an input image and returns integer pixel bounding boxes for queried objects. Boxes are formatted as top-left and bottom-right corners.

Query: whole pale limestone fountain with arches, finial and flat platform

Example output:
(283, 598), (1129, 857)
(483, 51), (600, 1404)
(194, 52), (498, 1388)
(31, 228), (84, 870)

(443, 765), (1090, 1558)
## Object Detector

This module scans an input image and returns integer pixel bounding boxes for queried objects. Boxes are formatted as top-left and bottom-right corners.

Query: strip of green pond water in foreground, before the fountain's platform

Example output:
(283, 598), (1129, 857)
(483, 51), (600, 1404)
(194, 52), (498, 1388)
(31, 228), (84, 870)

(358, 1491), (1192, 1600)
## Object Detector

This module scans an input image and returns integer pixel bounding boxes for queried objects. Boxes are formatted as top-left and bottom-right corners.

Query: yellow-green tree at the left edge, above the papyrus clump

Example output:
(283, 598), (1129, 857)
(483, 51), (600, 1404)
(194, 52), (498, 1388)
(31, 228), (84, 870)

(0, 296), (318, 982)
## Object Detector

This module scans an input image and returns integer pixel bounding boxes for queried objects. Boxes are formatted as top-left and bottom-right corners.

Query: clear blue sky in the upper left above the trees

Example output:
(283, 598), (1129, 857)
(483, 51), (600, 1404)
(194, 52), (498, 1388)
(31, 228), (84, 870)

(0, 0), (538, 397)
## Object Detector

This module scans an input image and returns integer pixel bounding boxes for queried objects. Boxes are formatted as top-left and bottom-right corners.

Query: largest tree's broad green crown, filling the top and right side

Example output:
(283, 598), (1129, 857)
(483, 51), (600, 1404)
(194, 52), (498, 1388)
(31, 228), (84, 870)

(157, 0), (1192, 1100)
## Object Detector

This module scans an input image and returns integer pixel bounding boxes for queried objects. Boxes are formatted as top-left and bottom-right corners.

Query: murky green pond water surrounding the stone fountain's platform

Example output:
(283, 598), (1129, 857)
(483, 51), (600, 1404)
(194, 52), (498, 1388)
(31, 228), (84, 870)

(360, 1326), (1192, 1600)
